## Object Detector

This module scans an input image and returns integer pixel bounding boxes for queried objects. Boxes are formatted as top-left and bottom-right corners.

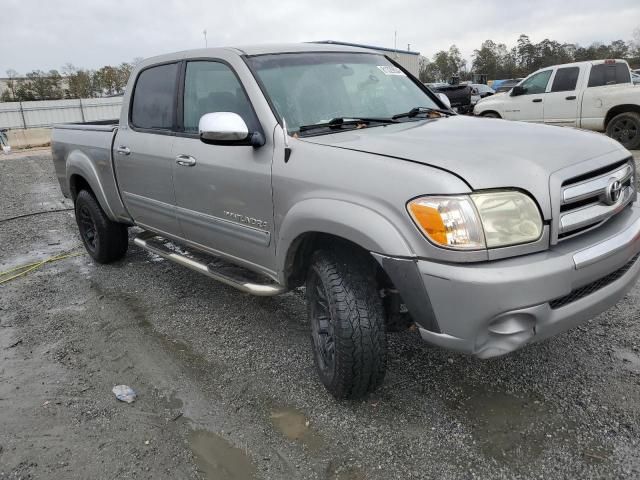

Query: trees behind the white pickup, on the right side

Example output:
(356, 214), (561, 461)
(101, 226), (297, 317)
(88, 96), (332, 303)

(419, 28), (640, 82)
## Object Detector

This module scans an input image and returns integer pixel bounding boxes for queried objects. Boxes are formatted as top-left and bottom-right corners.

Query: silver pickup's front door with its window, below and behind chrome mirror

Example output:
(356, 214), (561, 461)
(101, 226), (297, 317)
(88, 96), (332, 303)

(173, 60), (275, 269)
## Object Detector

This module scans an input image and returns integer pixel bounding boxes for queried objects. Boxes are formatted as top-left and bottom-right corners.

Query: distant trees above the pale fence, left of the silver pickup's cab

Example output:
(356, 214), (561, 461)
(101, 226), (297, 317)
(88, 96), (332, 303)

(0, 59), (140, 102)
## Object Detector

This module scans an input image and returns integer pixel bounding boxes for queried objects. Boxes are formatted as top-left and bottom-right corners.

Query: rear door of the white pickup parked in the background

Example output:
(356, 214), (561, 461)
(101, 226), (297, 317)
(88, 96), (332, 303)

(544, 66), (581, 127)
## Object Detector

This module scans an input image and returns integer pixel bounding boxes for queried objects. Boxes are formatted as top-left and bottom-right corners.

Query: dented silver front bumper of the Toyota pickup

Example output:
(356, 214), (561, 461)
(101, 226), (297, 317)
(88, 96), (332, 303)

(379, 205), (640, 358)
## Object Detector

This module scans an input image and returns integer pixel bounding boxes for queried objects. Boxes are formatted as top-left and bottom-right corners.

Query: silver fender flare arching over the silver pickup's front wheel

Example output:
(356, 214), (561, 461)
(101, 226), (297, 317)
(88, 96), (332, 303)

(276, 198), (415, 272)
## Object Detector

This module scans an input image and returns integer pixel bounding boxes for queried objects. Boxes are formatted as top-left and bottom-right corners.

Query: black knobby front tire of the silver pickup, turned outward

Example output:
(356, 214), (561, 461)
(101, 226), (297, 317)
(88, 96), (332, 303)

(306, 248), (387, 399)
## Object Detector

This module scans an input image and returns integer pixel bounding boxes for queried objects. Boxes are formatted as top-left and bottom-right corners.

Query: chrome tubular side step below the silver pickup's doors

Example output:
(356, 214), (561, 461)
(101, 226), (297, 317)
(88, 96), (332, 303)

(133, 231), (287, 297)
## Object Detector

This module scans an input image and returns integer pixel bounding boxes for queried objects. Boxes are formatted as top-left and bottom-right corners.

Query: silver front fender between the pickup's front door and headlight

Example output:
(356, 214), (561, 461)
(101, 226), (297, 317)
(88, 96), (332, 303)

(273, 133), (478, 280)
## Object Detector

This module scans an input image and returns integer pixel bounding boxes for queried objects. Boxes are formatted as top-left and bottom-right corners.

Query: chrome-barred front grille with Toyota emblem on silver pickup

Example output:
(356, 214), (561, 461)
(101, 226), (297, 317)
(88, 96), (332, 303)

(558, 160), (635, 240)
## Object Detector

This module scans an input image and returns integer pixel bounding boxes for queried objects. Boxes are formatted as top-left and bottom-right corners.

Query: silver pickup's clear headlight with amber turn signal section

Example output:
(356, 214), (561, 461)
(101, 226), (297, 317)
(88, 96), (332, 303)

(407, 191), (542, 250)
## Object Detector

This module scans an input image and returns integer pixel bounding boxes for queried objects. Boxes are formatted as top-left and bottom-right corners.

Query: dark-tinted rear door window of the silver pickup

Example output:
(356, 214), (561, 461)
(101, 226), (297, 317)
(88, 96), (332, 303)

(129, 63), (179, 131)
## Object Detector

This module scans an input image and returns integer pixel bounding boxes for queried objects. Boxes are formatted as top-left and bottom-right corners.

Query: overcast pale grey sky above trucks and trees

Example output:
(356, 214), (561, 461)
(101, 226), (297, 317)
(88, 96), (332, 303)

(0, 0), (640, 77)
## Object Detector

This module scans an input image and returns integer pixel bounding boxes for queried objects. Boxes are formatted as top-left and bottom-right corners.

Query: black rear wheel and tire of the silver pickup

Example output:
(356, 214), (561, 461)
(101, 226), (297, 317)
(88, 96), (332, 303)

(75, 190), (129, 263)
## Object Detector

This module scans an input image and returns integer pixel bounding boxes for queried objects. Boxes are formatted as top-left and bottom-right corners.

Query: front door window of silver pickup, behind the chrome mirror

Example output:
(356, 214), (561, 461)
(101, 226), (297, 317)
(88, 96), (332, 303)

(183, 61), (258, 133)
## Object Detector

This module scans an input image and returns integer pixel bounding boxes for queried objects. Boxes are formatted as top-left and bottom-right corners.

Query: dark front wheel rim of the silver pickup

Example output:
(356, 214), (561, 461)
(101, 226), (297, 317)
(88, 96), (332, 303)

(310, 275), (336, 372)
